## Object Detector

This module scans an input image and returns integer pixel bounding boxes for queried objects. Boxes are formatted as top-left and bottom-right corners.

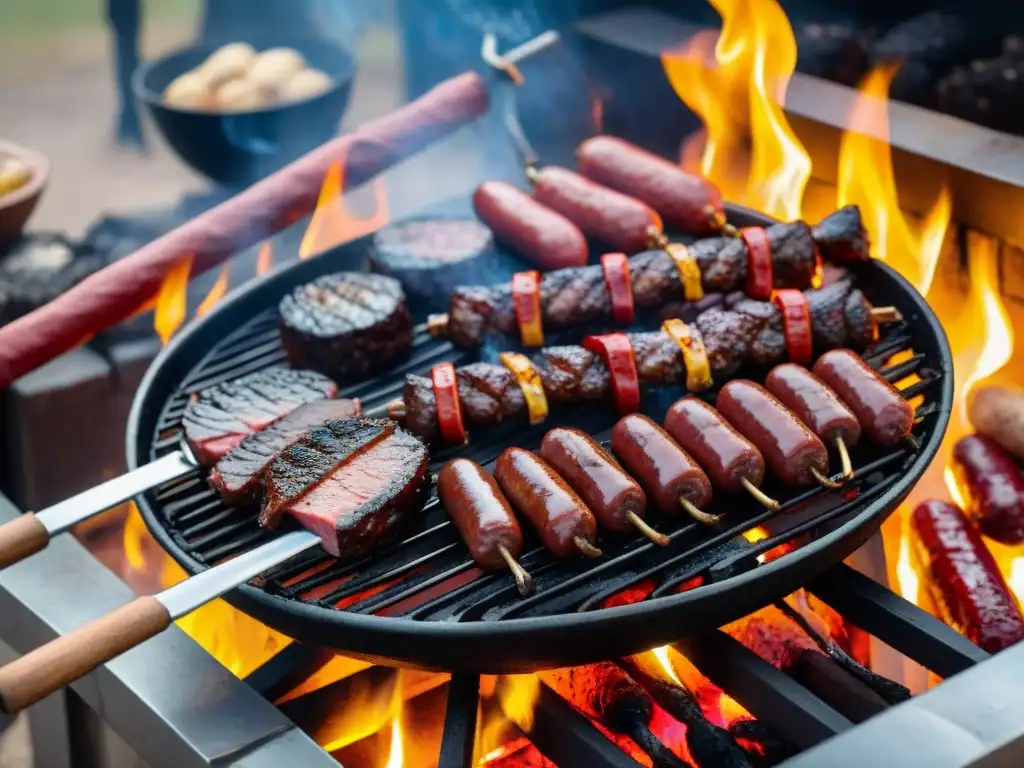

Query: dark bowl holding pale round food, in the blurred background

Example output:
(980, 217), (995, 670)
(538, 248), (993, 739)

(132, 35), (355, 187)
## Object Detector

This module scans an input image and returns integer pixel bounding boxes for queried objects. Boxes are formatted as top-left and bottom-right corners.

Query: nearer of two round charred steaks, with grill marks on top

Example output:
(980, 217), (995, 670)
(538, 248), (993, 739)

(280, 272), (413, 381)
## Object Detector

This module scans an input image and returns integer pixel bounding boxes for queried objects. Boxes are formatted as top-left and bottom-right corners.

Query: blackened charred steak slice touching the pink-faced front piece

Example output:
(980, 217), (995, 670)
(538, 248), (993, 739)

(259, 419), (395, 527)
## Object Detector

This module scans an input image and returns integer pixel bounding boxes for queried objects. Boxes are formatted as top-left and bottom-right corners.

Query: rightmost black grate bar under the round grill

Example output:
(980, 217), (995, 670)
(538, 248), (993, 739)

(807, 563), (989, 677)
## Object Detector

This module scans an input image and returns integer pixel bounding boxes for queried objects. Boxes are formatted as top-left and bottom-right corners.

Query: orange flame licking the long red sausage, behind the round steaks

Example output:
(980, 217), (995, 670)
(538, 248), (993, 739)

(299, 154), (388, 259)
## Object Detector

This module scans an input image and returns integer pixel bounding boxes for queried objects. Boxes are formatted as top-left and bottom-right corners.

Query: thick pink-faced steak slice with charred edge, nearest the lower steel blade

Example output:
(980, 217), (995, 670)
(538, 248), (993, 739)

(278, 429), (430, 557)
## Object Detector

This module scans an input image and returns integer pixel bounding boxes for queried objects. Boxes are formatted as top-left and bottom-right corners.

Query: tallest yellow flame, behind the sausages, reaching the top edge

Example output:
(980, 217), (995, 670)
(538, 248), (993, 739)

(662, 0), (811, 220)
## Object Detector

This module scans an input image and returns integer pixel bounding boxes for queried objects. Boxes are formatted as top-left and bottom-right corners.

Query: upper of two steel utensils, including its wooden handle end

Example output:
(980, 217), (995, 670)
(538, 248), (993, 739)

(0, 441), (199, 568)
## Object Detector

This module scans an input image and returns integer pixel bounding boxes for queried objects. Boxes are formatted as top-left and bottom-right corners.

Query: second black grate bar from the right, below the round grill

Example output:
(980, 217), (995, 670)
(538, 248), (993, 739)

(674, 630), (853, 749)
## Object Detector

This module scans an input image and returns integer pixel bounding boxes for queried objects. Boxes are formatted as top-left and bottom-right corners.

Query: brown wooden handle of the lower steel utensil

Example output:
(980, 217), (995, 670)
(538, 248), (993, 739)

(0, 597), (171, 715)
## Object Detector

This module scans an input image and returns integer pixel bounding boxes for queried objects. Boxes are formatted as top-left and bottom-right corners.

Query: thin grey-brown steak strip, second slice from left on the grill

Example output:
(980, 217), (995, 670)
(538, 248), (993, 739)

(210, 399), (362, 504)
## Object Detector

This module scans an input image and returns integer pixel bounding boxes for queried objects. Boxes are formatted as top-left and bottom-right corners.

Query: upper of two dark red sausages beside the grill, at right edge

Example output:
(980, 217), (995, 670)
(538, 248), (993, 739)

(952, 434), (1024, 544)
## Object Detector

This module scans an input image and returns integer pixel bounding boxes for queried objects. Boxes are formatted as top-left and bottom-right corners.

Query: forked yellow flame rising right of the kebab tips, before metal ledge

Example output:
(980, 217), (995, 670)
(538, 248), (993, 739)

(837, 63), (952, 295)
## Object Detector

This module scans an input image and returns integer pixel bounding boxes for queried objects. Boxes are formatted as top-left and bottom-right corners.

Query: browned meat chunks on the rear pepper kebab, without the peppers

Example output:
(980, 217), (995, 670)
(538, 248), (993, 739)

(446, 206), (864, 347)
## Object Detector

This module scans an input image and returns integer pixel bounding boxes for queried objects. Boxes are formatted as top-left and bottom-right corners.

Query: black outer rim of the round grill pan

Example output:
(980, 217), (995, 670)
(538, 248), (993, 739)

(127, 206), (953, 674)
